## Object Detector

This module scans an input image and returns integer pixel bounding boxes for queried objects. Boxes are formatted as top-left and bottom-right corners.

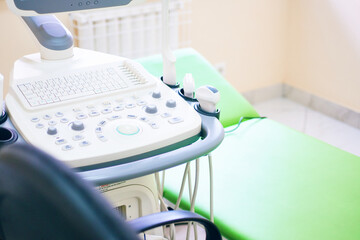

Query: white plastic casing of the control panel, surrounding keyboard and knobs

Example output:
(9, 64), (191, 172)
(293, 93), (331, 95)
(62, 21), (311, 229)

(6, 48), (201, 167)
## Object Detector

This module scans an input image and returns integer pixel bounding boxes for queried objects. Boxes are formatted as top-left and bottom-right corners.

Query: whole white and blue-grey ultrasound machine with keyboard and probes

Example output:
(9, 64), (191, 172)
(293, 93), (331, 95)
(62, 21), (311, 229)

(0, 0), (224, 235)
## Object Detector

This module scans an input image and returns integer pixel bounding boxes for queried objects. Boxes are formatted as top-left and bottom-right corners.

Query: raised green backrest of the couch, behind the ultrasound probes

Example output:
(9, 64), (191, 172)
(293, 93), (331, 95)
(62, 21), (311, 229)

(138, 49), (258, 127)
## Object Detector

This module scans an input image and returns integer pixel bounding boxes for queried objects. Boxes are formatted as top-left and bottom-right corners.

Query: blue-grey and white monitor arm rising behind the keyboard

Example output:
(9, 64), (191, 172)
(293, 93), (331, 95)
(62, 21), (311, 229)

(22, 15), (74, 60)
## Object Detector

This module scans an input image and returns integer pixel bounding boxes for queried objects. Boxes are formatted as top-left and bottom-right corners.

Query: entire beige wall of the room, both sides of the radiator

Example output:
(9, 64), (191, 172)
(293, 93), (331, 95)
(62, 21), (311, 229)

(0, 0), (360, 112)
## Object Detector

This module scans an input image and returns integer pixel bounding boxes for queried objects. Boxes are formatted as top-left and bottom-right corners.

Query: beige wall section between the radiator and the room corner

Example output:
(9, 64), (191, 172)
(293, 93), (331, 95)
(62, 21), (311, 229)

(191, 0), (287, 92)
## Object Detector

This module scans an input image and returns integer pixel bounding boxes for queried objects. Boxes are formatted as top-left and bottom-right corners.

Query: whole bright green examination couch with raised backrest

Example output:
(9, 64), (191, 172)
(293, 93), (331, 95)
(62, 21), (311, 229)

(139, 49), (360, 240)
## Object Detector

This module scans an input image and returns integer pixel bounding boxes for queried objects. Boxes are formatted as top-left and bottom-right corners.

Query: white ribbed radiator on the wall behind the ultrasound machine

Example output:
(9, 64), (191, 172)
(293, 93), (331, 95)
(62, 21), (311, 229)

(69, 0), (191, 58)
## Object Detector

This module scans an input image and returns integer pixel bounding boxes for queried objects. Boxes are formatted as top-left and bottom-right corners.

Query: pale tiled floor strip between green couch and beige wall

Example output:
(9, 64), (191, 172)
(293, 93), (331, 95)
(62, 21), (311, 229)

(254, 98), (360, 156)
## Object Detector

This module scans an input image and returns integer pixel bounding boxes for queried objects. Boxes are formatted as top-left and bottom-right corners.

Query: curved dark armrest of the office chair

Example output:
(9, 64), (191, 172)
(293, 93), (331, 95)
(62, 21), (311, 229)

(128, 211), (222, 240)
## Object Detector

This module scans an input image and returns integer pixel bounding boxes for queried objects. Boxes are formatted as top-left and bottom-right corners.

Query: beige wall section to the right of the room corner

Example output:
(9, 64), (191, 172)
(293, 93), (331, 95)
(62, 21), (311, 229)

(285, 0), (360, 112)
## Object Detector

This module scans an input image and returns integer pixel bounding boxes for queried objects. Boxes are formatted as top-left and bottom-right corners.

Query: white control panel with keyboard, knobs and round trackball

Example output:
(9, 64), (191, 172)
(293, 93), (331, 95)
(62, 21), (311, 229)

(6, 50), (201, 167)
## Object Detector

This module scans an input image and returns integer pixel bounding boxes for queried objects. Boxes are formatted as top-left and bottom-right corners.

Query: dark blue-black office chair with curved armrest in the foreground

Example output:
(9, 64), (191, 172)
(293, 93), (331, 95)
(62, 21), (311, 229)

(0, 144), (221, 240)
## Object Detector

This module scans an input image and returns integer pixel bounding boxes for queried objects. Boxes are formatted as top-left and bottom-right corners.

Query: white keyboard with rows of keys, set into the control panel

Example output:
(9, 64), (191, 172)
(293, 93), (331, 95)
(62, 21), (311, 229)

(17, 61), (147, 107)
